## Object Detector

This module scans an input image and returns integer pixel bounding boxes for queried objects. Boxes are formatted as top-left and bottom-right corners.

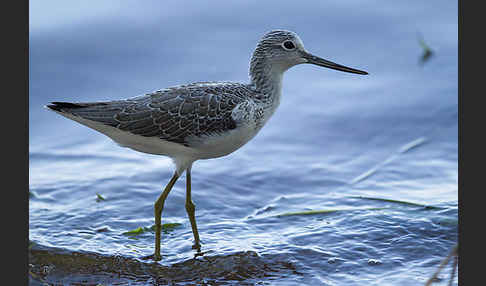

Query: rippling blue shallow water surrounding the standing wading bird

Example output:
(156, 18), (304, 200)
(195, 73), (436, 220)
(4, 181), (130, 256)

(29, 1), (458, 285)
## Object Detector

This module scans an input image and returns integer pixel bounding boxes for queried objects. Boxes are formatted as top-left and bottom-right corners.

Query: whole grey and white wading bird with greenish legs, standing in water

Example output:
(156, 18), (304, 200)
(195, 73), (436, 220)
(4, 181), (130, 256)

(47, 30), (367, 261)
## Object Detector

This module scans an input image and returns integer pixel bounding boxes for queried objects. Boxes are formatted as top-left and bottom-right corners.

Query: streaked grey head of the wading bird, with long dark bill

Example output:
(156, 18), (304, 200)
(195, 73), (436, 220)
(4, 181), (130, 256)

(250, 30), (368, 79)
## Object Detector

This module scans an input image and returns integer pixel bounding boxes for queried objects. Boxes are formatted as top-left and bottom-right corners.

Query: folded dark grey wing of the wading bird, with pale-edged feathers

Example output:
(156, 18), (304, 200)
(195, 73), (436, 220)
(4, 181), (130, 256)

(50, 83), (254, 146)
